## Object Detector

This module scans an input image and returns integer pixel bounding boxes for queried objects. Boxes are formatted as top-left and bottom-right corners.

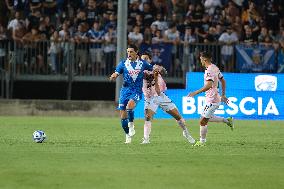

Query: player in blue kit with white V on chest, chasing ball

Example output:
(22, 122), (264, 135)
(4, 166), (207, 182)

(109, 45), (153, 143)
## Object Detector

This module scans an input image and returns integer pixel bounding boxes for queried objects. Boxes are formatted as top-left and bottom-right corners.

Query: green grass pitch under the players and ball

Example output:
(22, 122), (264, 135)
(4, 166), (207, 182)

(0, 117), (284, 189)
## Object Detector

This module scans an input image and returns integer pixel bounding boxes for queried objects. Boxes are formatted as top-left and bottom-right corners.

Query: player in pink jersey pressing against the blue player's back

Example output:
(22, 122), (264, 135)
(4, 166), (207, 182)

(141, 52), (195, 144)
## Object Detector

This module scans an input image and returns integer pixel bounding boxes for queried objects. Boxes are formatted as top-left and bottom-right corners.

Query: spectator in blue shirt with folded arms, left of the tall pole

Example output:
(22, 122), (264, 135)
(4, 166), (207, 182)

(88, 21), (105, 75)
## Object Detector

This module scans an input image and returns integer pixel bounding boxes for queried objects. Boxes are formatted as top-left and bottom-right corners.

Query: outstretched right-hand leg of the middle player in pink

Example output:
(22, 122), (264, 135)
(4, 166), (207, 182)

(166, 108), (195, 143)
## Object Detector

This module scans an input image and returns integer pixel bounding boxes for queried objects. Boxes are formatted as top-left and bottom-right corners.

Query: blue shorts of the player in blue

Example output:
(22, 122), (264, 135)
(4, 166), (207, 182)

(117, 87), (142, 110)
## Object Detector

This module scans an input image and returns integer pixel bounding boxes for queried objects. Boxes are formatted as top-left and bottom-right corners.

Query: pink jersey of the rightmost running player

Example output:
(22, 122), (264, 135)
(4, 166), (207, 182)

(204, 64), (223, 103)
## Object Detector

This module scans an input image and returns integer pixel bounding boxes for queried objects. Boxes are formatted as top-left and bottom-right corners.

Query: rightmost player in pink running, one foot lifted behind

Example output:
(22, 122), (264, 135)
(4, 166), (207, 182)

(188, 52), (234, 146)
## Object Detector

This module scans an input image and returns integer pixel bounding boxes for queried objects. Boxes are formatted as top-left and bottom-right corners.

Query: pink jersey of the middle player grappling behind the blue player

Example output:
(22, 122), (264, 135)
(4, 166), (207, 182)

(142, 66), (167, 99)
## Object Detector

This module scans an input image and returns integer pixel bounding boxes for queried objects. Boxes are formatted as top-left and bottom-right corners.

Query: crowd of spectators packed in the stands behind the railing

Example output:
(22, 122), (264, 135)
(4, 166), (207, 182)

(0, 0), (284, 75)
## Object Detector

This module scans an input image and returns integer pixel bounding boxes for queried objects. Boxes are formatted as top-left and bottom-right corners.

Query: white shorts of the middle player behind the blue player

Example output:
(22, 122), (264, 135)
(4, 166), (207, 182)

(144, 93), (177, 113)
